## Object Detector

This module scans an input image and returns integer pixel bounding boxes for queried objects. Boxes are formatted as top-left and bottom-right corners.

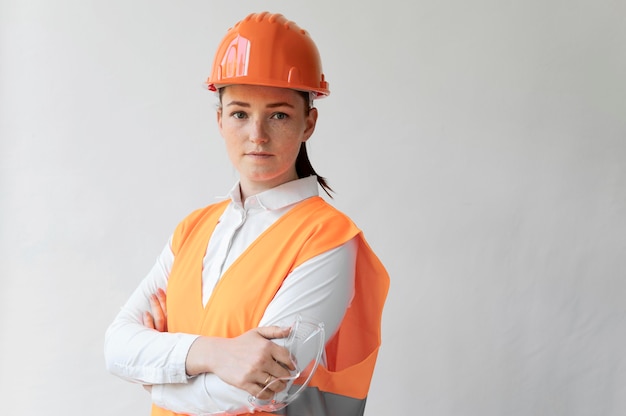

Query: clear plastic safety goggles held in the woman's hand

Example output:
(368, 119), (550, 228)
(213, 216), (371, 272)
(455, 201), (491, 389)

(248, 315), (325, 412)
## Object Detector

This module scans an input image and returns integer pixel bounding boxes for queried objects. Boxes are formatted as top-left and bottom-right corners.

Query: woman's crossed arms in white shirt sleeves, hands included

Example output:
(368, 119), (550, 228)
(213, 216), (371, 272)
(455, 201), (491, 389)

(105, 236), (357, 414)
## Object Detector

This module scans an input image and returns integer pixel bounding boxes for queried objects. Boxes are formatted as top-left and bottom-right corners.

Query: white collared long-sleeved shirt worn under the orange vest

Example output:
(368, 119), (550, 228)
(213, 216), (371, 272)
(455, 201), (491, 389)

(105, 176), (357, 414)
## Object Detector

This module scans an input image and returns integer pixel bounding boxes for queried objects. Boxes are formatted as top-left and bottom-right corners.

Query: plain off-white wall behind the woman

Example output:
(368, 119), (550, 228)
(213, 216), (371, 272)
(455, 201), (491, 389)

(0, 0), (626, 416)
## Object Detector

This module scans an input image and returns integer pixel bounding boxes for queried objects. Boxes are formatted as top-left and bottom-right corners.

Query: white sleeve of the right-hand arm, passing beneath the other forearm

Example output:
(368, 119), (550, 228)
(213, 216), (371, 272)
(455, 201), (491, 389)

(152, 239), (357, 414)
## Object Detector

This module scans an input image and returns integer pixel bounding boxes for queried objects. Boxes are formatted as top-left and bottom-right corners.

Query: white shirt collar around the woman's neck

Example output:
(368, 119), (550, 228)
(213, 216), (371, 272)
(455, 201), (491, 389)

(222, 175), (319, 210)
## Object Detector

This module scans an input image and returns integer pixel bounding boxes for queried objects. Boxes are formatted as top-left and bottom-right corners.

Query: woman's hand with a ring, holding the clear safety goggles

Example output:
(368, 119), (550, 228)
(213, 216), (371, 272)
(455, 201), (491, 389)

(186, 326), (295, 399)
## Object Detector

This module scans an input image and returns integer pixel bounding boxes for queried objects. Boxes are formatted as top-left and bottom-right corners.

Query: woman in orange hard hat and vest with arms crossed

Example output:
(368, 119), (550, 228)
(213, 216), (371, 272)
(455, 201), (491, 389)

(105, 13), (389, 415)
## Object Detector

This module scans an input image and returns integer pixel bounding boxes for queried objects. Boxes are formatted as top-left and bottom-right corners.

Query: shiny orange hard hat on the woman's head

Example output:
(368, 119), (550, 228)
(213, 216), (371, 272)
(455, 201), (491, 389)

(206, 12), (330, 98)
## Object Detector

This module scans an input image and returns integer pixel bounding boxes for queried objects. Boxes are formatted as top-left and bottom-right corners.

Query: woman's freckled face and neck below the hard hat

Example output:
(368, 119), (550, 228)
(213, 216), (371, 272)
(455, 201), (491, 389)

(217, 85), (317, 198)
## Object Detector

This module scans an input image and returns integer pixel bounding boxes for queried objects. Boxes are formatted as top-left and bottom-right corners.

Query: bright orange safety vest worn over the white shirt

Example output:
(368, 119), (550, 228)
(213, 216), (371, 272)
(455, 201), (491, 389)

(152, 196), (389, 415)
